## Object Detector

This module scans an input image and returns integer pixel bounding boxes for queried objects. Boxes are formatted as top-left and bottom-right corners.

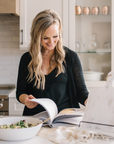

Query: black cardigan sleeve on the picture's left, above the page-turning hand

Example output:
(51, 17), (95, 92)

(16, 52), (30, 102)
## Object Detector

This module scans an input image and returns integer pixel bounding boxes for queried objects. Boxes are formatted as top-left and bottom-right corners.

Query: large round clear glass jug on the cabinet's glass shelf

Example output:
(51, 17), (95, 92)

(86, 33), (99, 52)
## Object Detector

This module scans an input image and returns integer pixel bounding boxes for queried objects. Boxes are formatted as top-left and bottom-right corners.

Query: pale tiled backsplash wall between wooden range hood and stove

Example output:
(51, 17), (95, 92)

(0, 14), (25, 84)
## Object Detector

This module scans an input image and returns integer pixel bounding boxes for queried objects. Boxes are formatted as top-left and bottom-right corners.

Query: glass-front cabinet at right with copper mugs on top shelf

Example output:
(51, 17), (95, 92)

(69, 0), (114, 87)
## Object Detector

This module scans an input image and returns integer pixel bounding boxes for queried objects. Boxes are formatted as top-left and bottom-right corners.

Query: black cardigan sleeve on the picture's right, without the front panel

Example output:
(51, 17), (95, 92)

(71, 52), (88, 105)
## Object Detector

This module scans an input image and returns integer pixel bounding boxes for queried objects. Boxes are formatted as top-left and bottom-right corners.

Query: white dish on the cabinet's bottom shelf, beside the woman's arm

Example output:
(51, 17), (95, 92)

(83, 71), (103, 81)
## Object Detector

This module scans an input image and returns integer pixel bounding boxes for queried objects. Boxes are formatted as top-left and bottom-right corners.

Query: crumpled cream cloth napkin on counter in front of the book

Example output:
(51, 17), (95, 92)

(37, 126), (108, 144)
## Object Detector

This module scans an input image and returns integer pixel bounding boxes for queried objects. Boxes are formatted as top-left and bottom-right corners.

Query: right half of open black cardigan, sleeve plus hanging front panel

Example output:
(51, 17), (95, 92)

(64, 47), (88, 108)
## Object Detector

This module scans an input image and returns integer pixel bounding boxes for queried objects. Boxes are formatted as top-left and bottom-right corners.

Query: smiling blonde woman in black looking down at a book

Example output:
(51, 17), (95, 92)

(16, 10), (88, 115)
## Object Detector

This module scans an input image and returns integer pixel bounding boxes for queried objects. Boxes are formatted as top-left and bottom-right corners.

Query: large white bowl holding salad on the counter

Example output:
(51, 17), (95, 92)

(0, 116), (42, 141)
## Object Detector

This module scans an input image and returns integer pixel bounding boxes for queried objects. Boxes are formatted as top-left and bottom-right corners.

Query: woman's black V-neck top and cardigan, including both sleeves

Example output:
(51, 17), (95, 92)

(16, 47), (88, 115)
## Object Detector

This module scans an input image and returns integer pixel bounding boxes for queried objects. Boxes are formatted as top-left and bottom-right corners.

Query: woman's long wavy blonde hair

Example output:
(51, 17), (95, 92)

(28, 10), (65, 89)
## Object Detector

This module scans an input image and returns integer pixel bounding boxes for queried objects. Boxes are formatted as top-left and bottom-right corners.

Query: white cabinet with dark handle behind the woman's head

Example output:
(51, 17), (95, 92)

(20, 0), (68, 50)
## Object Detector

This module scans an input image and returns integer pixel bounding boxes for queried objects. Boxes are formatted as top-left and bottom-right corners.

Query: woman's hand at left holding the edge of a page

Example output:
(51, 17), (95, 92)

(24, 95), (38, 109)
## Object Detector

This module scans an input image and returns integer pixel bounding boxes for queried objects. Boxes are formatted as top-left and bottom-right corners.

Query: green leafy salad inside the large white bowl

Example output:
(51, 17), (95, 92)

(0, 120), (38, 129)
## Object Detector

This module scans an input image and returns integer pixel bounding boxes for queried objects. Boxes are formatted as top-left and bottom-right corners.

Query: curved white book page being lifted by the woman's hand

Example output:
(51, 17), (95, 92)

(30, 98), (58, 123)
